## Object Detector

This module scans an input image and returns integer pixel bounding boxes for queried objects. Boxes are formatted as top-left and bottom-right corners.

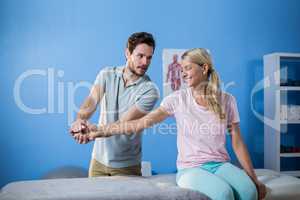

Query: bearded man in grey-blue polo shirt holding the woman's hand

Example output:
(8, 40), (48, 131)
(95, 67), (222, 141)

(70, 32), (159, 177)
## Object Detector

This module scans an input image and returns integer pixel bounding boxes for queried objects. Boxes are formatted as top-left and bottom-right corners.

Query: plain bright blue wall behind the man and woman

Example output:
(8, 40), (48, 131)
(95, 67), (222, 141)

(0, 0), (300, 187)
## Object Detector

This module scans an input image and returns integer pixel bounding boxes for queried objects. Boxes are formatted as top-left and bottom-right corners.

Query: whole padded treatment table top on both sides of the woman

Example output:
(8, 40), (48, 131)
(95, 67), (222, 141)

(0, 169), (300, 200)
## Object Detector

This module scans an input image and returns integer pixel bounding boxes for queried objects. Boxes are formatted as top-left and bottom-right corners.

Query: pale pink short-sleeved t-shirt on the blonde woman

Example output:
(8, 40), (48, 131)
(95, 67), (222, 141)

(160, 88), (240, 169)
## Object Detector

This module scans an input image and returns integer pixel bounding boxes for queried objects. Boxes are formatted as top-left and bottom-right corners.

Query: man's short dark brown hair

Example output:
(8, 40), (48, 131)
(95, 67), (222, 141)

(127, 32), (155, 53)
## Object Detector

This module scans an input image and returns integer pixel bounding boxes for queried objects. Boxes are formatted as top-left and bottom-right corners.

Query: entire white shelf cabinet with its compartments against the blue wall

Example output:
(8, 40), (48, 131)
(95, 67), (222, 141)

(264, 53), (300, 176)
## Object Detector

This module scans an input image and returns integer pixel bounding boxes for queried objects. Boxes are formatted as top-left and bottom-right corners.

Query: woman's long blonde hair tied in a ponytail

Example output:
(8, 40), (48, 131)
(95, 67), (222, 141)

(181, 48), (225, 120)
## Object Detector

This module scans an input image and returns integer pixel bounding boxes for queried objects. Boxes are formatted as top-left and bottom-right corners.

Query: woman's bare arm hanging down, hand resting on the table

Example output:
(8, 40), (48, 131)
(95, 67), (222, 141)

(231, 123), (266, 199)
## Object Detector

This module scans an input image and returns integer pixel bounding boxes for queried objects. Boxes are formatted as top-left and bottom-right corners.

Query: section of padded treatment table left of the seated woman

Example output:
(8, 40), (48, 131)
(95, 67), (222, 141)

(0, 174), (209, 200)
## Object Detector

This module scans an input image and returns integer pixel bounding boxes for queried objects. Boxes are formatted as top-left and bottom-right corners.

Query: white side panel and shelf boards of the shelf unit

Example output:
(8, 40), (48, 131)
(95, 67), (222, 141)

(264, 53), (300, 177)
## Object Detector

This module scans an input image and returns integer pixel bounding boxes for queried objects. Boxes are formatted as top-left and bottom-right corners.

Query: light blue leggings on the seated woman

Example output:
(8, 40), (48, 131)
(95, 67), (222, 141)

(176, 162), (257, 200)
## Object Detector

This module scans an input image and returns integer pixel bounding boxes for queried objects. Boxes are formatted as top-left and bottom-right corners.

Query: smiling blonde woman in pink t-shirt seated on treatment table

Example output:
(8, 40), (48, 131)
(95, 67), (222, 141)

(75, 48), (266, 200)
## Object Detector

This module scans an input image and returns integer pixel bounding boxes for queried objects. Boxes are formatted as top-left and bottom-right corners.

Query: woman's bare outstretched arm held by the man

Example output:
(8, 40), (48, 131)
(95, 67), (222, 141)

(89, 107), (169, 138)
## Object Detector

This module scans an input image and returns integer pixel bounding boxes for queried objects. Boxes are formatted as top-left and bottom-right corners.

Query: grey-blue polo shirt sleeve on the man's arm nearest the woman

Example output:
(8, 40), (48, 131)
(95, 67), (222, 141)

(135, 83), (159, 113)
